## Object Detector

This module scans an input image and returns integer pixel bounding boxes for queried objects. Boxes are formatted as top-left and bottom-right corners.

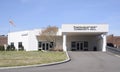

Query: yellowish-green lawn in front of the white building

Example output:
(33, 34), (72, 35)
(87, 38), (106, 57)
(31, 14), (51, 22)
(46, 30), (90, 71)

(0, 51), (66, 67)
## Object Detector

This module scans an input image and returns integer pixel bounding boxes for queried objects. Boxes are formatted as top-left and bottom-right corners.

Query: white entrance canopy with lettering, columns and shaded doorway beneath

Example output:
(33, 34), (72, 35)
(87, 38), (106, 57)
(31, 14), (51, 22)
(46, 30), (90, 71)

(62, 24), (108, 51)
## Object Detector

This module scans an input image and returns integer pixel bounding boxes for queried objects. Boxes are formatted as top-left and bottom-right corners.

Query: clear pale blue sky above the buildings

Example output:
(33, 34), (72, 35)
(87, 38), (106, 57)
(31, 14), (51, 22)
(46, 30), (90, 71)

(0, 0), (120, 36)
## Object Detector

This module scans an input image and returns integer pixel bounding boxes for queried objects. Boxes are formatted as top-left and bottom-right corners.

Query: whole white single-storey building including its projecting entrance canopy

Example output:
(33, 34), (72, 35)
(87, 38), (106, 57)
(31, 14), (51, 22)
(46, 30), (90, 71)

(8, 24), (108, 52)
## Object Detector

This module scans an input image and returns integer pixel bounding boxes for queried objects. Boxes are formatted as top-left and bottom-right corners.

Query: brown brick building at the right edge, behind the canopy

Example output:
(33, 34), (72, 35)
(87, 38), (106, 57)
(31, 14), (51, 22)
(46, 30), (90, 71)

(107, 34), (120, 48)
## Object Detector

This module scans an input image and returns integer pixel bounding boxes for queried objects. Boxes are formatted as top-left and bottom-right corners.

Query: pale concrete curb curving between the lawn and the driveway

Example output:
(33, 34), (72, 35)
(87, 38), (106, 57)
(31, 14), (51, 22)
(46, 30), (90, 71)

(0, 51), (71, 69)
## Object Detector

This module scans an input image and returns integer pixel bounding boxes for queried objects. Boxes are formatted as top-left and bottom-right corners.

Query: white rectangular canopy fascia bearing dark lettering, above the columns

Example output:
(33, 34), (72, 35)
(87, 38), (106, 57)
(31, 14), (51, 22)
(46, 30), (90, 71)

(62, 24), (108, 33)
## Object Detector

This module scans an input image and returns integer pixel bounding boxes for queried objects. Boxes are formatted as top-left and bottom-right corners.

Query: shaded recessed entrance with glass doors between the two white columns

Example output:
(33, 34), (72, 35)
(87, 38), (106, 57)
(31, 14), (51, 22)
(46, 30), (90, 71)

(66, 33), (100, 51)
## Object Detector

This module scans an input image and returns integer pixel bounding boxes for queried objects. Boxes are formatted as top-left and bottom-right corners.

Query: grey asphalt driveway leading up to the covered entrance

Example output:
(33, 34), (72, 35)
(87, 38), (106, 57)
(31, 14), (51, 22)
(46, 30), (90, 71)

(0, 52), (120, 72)
